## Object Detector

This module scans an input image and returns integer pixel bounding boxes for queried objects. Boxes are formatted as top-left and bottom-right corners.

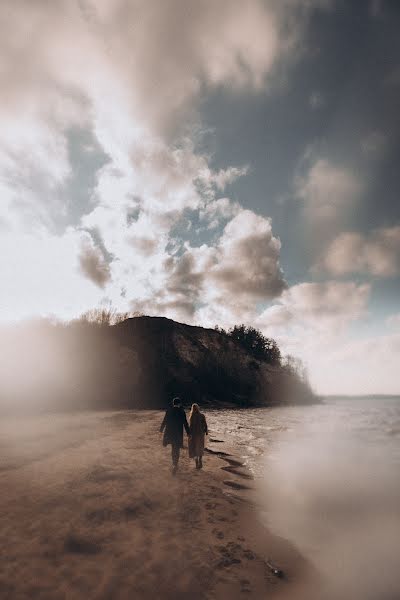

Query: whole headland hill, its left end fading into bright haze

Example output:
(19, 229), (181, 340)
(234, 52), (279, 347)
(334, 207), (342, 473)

(0, 316), (316, 409)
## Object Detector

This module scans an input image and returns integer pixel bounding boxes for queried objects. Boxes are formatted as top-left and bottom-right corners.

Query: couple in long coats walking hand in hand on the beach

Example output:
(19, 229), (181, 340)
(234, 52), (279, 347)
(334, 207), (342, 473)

(160, 398), (208, 474)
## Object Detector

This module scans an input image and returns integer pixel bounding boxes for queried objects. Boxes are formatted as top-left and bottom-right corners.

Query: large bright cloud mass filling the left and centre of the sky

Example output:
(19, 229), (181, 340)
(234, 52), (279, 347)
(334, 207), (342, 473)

(0, 0), (319, 320)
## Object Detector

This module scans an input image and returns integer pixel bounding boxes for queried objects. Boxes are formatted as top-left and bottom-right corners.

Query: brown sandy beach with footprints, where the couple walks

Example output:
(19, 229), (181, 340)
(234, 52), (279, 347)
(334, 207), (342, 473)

(0, 411), (308, 600)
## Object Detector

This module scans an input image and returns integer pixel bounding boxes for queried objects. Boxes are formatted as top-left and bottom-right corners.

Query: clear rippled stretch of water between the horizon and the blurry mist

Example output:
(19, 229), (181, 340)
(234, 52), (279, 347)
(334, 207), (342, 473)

(207, 397), (400, 476)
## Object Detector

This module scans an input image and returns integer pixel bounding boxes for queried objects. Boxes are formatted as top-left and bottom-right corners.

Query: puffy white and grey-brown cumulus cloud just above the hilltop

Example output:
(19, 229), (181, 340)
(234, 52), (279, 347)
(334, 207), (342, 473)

(125, 209), (286, 326)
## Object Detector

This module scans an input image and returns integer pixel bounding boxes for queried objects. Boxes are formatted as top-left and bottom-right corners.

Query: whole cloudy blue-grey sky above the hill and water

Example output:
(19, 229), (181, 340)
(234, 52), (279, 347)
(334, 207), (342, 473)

(0, 0), (400, 394)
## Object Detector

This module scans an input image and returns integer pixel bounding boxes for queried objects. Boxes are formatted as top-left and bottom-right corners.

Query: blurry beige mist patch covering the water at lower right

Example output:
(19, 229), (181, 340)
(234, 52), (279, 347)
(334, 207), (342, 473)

(261, 408), (400, 600)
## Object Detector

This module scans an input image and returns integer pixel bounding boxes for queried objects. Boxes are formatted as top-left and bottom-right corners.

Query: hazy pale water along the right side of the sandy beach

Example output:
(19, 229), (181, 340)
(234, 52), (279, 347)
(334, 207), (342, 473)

(208, 397), (400, 600)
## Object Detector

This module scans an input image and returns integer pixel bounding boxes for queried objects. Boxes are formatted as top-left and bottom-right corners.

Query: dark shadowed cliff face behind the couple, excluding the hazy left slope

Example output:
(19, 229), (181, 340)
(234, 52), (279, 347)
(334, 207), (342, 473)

(112, 317), (315, 407)
